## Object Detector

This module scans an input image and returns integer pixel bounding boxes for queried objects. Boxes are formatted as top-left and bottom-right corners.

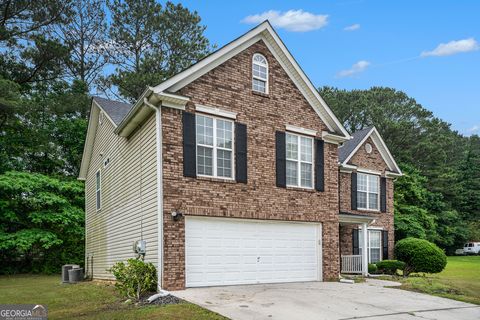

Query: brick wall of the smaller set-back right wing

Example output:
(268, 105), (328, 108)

(339, 138), (394, 258)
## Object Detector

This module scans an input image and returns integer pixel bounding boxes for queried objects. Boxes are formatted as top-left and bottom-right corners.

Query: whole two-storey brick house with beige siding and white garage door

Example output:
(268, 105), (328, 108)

(79, 22), (401, 290)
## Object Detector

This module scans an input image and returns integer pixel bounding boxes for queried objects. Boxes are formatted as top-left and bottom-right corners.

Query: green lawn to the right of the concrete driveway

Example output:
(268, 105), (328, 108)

(399, 256), (480, 304)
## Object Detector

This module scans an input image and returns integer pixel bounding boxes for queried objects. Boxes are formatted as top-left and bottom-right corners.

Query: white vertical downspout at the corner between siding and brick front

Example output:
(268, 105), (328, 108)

(143, 98), (163, 292)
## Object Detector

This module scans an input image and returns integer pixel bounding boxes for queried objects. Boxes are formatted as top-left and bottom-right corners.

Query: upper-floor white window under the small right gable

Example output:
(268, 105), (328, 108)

(357, 173), (380, 210)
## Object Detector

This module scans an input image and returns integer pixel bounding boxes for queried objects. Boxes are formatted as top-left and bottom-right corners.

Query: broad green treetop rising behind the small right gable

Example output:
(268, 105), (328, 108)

(319, 87), (462, 170)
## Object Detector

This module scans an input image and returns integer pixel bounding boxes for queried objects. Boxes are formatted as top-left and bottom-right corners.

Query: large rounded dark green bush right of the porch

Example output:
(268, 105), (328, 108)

(395, 238), (447, 276)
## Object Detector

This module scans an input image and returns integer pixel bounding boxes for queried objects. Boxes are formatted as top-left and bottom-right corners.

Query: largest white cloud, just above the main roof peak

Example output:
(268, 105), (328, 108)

(242, 9), (328, 32)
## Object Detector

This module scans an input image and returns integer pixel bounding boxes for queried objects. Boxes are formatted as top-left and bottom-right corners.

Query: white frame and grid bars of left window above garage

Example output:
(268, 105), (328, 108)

(195, 112), (235, 181)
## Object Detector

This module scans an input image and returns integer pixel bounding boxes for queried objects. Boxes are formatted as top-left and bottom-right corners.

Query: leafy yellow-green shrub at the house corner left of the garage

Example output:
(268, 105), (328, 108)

(109, 259), (157, 300)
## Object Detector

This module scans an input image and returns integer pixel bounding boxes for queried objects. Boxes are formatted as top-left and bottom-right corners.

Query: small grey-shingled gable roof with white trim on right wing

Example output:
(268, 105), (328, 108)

(338, 127), (402, 176)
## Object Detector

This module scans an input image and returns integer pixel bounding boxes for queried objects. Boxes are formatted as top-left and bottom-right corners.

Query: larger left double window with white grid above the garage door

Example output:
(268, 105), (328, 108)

(196, 114), (233, 179)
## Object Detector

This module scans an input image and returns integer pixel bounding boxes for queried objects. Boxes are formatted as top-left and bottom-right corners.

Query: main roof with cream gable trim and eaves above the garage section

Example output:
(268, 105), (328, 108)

(79, 21), (351, 180)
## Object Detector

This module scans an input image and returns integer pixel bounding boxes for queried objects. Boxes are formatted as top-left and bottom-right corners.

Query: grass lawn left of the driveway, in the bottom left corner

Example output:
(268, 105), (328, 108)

(0, 275), (226, 320)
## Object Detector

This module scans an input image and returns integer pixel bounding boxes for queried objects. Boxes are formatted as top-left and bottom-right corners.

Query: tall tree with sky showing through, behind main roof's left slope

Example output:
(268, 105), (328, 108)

(102, 0), (211, 101)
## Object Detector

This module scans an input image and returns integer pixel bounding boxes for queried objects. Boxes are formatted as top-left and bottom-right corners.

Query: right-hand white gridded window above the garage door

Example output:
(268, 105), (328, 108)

(285, 133), (313, 188)
